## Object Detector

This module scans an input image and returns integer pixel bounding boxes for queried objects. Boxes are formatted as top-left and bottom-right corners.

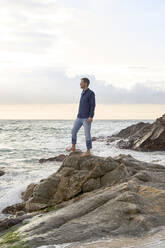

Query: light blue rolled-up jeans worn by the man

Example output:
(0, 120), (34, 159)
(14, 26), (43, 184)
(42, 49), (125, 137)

(71, 117), (92, 149)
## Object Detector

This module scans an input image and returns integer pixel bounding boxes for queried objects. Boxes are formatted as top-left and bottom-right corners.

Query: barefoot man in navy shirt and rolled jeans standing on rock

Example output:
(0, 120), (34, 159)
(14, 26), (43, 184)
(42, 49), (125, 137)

(66, 78), (96, 156)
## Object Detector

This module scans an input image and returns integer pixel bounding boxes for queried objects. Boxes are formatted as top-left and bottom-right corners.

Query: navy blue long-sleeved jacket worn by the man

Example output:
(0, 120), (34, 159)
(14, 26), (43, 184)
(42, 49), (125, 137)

(77, 88), (96, 118)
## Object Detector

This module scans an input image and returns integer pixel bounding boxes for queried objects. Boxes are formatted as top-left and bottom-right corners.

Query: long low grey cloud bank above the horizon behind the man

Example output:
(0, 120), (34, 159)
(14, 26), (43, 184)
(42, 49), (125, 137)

(0, 67), (165, 104)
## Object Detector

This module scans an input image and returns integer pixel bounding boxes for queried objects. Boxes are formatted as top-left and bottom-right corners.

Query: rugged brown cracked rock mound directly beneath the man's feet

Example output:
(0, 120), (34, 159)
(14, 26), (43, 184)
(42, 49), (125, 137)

(23, 152), (127, 212)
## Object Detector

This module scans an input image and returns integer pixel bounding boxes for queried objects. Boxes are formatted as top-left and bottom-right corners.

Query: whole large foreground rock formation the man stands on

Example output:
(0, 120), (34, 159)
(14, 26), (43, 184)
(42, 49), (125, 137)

(2, 152), (165, 248)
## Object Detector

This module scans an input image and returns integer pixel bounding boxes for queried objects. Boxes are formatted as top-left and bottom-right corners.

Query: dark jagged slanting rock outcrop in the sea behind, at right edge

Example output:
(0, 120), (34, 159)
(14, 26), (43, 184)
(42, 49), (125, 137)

(107, 114), (165, 151)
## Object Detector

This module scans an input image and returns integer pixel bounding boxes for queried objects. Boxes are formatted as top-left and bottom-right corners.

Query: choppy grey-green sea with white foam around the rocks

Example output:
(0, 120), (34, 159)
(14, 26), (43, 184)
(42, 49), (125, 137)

(0, 119), (165, 247)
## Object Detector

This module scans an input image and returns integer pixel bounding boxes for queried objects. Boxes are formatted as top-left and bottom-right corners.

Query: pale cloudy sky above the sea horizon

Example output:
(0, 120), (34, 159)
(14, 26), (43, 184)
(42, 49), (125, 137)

(0, 0), (165, 118)
